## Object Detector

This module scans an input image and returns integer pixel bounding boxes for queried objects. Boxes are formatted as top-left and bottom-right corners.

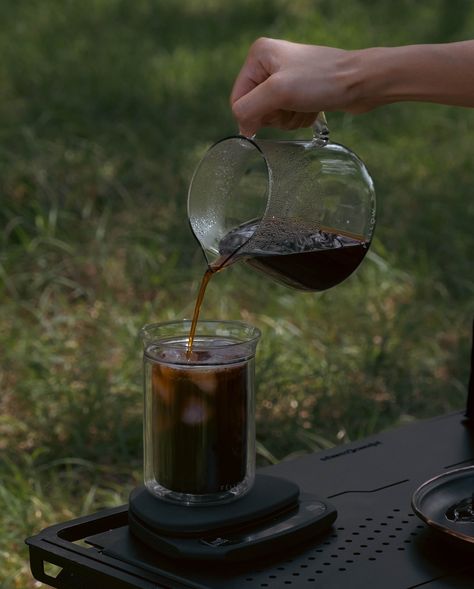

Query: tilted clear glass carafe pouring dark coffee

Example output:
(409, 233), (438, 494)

(188, 113), (375, 291)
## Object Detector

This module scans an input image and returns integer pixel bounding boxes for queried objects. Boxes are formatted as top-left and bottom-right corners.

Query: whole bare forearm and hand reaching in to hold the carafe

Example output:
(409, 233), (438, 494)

(230, 38), (474, 136)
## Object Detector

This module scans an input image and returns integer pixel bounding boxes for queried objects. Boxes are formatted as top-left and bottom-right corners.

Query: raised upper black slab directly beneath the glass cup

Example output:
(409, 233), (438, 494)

(129, 474), (300, 537)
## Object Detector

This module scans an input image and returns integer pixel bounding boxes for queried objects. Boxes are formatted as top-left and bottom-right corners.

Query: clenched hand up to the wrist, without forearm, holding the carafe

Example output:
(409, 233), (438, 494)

(230, 38), (371, 136)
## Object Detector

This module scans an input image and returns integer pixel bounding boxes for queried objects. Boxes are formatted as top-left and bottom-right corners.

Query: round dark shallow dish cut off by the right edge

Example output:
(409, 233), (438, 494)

(412, 466), (474, 543)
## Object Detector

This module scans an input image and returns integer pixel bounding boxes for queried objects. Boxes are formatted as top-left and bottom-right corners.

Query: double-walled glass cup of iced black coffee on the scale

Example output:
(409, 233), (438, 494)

(141, 320), (260, 505)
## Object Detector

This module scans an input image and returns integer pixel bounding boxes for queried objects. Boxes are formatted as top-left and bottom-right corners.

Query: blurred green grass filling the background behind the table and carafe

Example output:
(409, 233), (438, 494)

(0, 0), (474, 588)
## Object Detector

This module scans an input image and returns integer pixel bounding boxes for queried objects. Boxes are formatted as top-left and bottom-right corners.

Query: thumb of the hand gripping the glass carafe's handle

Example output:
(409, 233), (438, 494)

(232, 76), (279, 137)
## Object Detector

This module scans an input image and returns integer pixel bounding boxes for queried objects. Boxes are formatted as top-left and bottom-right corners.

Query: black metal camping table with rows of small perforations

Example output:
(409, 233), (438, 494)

(27, 413), (474, 589)
